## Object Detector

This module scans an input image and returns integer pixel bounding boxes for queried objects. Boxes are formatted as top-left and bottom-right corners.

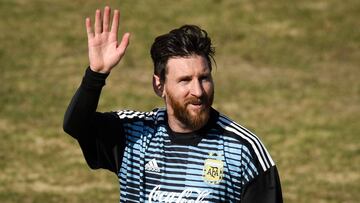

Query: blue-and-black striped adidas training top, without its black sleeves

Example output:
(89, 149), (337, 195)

(116, 109), (274, 202)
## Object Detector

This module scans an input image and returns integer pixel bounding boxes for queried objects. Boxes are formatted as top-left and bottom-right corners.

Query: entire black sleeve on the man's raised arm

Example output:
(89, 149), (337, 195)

(63, 68), (125, 173)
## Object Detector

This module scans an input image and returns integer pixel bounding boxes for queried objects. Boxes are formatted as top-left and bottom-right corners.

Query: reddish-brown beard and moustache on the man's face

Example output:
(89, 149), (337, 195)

(167, 92), (214, 130)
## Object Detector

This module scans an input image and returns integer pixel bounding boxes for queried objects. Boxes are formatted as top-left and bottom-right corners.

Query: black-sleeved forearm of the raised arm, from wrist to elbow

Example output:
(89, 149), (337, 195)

(63, 68), (108, 138)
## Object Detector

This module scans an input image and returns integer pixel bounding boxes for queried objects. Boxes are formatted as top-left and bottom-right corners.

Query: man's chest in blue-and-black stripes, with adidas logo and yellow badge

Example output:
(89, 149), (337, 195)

(119, 127), (243, 203)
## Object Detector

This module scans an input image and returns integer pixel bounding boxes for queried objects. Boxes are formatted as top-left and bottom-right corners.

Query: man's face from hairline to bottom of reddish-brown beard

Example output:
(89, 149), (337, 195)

(163, 55), (214, 131)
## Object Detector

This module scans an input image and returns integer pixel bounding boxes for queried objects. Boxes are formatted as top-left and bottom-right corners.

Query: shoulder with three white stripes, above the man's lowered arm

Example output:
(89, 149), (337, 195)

(212, 110), (275, 172)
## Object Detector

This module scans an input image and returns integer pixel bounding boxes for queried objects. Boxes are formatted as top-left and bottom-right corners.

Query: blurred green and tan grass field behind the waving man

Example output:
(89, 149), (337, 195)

(0, 0), (360, 203)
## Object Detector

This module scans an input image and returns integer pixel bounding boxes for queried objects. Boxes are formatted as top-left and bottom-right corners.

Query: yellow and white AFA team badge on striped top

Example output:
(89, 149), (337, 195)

(203, 154), (224, 184)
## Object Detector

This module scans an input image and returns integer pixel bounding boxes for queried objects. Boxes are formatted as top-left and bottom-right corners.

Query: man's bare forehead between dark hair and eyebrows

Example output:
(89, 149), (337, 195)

(166, 55), (211, 77)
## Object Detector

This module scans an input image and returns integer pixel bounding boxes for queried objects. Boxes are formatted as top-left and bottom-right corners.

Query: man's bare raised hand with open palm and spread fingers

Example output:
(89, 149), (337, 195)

(86, 6), (130, 73)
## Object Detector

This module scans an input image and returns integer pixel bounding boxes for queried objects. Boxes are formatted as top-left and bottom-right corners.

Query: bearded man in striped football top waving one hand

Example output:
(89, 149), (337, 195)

(64, 7), (282, 203)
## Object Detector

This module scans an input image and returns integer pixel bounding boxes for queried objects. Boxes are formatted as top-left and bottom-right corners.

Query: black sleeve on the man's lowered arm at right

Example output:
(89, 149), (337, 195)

(241, 166), (283, 203)
